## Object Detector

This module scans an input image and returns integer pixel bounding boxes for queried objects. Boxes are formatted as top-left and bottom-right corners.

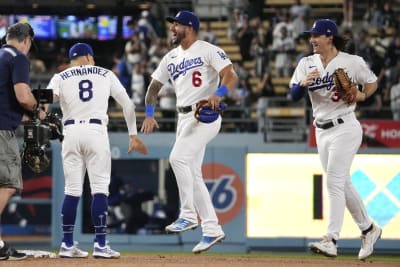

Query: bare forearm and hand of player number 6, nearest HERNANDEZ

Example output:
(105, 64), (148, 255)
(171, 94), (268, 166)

(140, 79), (163, 134)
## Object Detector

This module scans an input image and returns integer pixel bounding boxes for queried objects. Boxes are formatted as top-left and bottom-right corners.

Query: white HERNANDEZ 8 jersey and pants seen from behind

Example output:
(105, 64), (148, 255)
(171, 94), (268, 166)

(47, 65), (137, 196)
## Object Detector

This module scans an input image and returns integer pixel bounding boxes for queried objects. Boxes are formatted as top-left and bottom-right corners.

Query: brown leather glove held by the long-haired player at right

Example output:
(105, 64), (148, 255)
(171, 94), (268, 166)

(333, 68), (358, 105)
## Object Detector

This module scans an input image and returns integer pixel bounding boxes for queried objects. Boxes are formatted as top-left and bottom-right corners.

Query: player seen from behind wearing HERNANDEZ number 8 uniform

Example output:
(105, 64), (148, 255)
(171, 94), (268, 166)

(48, 43), (147, 258)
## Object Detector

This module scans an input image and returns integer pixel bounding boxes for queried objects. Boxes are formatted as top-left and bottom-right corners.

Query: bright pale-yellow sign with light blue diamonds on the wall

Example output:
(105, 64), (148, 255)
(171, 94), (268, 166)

(246, 153), (400, 239)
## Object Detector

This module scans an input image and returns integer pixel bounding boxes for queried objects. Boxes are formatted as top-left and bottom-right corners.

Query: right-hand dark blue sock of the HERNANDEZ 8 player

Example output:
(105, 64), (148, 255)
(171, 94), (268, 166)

(92, 194), (108, 247)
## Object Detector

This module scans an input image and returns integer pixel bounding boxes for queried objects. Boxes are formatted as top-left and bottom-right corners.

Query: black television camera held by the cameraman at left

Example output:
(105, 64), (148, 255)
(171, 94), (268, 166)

(21, 88), (63, 173)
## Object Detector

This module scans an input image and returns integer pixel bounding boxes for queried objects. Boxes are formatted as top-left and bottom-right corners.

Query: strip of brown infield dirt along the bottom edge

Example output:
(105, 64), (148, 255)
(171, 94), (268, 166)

(0, 253), (400, 267)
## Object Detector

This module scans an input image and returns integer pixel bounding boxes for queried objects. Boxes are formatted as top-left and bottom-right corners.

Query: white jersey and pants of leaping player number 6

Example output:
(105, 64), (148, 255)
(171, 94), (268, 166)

(152, 40), (231, 236)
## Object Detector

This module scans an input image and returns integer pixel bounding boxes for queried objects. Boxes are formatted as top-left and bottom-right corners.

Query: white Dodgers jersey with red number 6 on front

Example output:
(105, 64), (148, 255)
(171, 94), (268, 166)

(151, 40), (232, 107)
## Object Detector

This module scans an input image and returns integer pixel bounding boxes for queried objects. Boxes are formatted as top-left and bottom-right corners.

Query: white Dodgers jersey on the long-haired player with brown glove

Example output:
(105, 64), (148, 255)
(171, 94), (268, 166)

(290, 52), (377, 121)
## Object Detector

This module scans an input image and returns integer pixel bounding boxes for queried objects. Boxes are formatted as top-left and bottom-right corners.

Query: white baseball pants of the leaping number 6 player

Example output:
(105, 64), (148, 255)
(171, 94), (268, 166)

(169, 111), (223, 236)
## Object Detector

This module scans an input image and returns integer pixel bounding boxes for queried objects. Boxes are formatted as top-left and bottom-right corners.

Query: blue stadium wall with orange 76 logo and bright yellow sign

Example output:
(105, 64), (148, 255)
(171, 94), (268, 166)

(51, 133), (400, 253)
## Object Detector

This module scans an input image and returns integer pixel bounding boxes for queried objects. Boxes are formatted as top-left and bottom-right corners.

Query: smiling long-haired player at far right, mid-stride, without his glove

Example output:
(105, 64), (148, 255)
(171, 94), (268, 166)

(290, 19), (382, 260)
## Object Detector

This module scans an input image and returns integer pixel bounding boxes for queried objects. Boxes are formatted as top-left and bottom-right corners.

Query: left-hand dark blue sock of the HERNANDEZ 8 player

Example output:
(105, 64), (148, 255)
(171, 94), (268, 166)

(61, 195), (79, 247)
